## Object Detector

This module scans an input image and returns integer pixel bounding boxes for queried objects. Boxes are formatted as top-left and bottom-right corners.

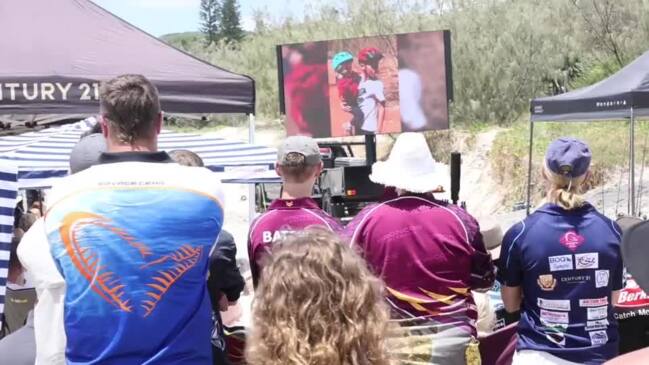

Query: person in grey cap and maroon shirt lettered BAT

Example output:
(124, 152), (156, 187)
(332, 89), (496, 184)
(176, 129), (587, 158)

(248, 136), (342, 286)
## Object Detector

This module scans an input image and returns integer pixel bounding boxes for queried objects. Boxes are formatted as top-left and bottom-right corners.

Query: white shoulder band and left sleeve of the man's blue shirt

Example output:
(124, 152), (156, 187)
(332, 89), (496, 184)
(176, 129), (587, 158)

(18, 162), (223, 365)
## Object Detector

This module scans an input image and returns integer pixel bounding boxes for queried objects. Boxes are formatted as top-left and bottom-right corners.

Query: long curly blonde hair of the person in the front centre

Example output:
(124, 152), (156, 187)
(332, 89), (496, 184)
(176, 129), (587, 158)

(246, 228), (390, 365)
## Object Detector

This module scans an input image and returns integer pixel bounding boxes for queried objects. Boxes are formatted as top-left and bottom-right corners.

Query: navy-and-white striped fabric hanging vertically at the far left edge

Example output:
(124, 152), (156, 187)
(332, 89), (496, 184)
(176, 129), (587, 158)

(0, 164), (18, 327)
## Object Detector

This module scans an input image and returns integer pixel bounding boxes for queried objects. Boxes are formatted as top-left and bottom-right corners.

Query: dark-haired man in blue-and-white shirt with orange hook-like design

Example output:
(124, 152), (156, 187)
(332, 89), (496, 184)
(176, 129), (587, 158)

(20, 75), (224, 365)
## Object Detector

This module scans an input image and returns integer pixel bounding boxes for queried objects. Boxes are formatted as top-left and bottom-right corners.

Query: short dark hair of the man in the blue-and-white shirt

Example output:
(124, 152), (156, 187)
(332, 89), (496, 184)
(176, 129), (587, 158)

(99, 75), (160, 144)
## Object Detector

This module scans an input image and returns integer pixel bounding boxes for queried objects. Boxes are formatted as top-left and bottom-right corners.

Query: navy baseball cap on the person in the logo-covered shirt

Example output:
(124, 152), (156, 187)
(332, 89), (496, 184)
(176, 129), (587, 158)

(545, 137), (591, 178)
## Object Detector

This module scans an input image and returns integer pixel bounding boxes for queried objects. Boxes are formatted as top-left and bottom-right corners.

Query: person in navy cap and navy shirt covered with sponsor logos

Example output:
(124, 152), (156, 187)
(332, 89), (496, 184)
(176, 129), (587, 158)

(498, 137), (624, 365)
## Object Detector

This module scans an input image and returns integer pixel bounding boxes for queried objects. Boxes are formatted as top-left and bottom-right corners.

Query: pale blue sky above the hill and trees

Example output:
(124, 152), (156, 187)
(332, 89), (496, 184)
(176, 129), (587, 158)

(92, 0), (304, 36)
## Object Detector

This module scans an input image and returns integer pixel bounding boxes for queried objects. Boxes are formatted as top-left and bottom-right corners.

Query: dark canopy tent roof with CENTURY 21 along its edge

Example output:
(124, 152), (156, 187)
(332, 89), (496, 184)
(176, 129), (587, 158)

(0, 0), (255, 114)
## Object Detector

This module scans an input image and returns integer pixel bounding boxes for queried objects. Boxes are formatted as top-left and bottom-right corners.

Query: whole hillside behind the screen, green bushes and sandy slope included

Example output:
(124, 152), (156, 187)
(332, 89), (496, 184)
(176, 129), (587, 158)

(163, 0), (649, 213)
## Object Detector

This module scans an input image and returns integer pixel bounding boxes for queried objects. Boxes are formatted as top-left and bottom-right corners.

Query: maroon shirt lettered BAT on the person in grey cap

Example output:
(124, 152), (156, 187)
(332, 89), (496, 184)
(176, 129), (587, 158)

(248, 198), (342, 286)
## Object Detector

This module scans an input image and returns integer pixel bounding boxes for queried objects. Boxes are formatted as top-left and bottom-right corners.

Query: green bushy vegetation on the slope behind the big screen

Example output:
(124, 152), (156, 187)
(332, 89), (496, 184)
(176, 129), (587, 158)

(166, 0), (649, 126)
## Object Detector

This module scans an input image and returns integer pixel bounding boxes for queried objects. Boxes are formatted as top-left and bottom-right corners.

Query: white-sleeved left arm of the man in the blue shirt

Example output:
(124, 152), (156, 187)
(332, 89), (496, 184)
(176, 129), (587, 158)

(18, 218), (67, 365)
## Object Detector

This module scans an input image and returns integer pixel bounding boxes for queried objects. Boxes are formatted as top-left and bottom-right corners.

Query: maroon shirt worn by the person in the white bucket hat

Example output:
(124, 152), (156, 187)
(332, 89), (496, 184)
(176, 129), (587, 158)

(345, 195), (495, 335)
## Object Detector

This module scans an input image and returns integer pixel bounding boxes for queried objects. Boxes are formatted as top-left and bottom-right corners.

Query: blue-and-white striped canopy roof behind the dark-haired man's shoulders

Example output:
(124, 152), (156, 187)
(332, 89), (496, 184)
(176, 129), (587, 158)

(0, 118), (277, 189)
